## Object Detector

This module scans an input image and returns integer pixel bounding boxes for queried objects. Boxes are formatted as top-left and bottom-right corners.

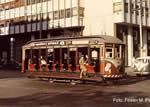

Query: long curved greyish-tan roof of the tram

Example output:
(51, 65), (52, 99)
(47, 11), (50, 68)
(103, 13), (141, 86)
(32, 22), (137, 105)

(27, 35), (124, 44)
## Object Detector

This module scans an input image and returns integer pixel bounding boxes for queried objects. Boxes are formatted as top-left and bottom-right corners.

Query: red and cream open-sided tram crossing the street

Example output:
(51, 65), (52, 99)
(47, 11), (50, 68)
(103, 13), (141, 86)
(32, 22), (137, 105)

(22, 35), (125, 81)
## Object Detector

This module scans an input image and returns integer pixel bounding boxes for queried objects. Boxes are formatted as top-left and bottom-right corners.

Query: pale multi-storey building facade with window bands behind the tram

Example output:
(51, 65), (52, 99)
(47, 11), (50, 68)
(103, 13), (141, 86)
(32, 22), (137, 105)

(0, 0), (150, 66)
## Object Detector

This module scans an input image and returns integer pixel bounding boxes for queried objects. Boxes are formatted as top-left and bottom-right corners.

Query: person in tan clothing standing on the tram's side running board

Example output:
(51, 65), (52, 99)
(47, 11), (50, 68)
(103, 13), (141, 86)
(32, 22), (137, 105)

(79, 56), (87, 78)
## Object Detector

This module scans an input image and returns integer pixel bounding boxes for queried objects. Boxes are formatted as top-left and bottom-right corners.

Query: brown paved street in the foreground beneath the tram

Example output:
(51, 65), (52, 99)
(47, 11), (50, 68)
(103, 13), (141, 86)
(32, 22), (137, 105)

(0, 70), (150, 107)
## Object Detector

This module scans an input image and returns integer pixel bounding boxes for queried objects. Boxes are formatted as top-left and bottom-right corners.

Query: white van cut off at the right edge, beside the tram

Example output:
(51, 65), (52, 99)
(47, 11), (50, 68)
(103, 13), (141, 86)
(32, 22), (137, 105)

(133, 56), (150, 76)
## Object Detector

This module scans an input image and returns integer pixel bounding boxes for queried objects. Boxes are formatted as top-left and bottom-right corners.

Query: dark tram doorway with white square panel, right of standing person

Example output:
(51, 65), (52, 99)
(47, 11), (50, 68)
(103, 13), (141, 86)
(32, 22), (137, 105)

(90, 46), (100, 72)
